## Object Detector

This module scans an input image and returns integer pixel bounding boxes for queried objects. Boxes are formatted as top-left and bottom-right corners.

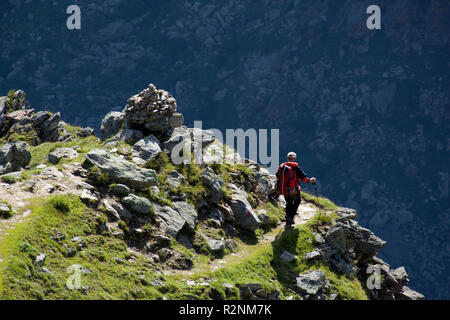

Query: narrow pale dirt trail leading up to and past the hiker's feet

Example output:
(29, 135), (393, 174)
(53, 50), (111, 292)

(162, 201), (318, 279)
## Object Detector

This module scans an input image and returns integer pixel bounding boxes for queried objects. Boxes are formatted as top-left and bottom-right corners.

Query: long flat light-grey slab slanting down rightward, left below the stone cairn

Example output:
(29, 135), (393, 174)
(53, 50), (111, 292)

(86, 149), (158, 189)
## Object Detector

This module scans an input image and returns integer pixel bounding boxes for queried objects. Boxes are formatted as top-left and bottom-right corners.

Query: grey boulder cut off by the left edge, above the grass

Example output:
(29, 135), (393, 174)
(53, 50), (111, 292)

(0, 141), (31, 175)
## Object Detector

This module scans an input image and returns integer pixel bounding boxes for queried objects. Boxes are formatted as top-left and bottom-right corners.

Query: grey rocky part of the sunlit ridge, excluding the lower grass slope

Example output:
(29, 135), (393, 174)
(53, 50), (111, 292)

(0, 84), (424, 300)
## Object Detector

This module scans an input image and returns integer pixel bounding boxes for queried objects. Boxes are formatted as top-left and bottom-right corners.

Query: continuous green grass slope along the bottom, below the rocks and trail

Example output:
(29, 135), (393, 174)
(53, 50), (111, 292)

(0, 195), (367, 299)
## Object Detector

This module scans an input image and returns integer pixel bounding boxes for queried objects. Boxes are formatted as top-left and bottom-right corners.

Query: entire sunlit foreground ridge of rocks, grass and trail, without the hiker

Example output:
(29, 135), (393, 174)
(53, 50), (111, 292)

(0, 84), (425, 300)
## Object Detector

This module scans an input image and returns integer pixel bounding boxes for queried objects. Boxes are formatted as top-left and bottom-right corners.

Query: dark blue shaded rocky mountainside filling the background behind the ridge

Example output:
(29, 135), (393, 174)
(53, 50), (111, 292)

(0, 0), (450, 298)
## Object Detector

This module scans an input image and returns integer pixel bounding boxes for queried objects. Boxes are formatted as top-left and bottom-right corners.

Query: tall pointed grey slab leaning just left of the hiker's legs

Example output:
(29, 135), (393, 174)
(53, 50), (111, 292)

(228, 184), (261, 231)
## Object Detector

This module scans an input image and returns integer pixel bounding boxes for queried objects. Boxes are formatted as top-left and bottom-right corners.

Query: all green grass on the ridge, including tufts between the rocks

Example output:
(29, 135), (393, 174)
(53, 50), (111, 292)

(0, 137), (367, 299)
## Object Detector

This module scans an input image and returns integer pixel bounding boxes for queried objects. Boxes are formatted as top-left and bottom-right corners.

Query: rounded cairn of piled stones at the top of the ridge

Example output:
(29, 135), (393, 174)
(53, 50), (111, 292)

(123, 84), (183, 132)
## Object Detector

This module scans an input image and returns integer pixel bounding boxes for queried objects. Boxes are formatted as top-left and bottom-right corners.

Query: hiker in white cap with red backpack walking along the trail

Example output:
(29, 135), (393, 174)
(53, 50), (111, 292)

(277, 152), (316, 226)
